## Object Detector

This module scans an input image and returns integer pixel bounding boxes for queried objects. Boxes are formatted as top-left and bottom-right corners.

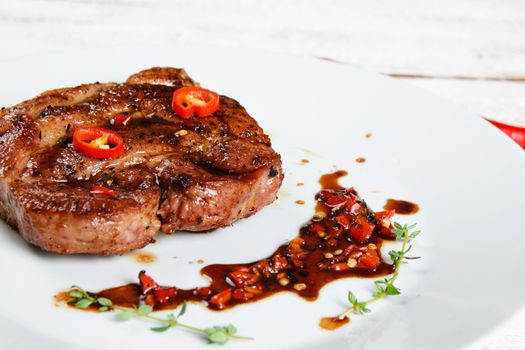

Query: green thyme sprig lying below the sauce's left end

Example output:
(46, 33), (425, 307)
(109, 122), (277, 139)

(69, 286), (253, 345)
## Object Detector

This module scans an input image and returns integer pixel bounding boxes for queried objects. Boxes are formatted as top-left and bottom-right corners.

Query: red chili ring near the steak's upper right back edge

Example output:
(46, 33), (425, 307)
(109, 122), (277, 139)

(171, 86), (219, 118)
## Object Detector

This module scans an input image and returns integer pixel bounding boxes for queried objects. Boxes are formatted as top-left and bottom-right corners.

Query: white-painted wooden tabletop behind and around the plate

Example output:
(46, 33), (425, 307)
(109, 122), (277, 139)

(0, 0), (525, 350)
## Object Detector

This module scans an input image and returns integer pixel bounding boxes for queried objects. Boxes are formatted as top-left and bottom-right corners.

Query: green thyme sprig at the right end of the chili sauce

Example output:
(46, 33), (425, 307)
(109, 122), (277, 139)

(338, 222), (421, 319)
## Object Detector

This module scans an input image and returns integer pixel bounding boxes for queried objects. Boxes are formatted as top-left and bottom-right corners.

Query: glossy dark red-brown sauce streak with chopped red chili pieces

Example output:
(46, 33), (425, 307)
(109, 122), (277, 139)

(61, 170), (393, 312)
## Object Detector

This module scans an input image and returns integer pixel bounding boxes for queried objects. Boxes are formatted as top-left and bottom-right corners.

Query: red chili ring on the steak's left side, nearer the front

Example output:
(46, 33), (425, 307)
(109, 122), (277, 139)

(73, 126), (124, 159)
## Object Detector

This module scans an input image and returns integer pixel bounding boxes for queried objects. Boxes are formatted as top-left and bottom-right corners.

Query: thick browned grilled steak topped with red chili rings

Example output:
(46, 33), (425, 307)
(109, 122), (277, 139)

(0, 68), (283, 255)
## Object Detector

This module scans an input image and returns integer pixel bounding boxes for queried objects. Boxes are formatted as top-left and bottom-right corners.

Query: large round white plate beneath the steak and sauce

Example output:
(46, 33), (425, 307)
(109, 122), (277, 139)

(0, 47), (525, 350)
